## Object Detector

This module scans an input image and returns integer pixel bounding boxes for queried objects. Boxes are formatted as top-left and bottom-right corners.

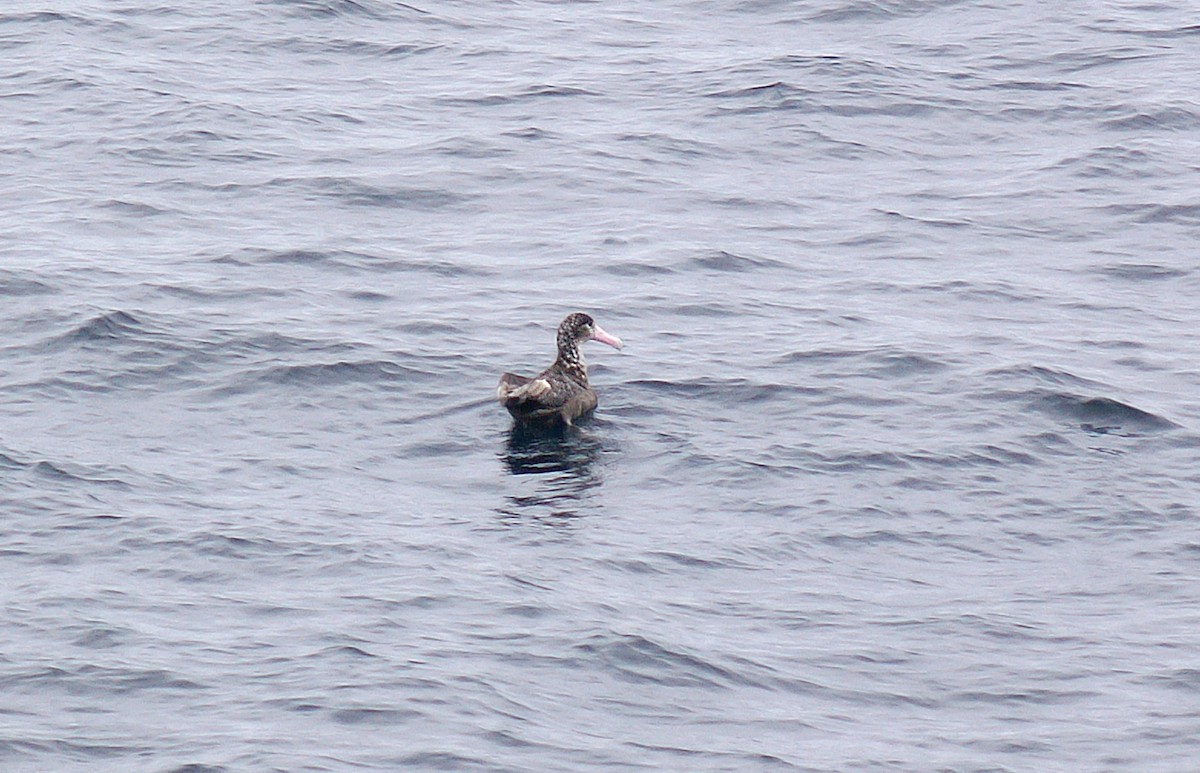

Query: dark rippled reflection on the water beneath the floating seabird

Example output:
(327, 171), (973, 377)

(497, 425), (607, 522)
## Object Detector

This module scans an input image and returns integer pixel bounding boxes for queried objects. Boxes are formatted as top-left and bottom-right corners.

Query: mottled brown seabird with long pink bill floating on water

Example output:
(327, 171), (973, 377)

(496, 312), (624, 426)
